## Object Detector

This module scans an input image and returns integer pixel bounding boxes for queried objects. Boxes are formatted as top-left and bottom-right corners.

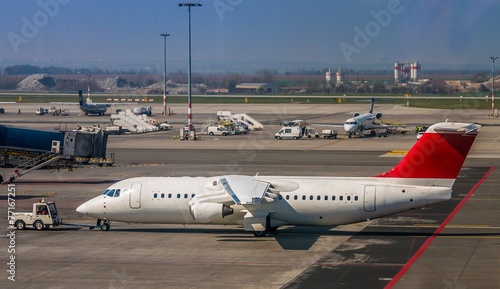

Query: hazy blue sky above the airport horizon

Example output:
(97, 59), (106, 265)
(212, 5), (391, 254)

(0, 0), (500, 72)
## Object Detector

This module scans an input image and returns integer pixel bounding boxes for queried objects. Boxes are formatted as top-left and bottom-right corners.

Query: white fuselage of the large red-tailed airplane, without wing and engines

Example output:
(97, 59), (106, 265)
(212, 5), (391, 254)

(78, 176), (451, 227)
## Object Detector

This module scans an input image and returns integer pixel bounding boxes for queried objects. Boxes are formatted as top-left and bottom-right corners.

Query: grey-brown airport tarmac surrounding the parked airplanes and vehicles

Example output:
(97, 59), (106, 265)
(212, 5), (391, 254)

(0, 103), (500, 288)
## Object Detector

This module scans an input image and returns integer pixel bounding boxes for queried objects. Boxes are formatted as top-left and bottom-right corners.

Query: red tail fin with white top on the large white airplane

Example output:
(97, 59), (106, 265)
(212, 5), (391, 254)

(377, 122), (479, 179)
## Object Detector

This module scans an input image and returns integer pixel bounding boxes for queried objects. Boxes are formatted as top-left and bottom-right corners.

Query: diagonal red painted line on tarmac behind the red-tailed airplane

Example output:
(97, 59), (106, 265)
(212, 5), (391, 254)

(384, 167), (495, 289)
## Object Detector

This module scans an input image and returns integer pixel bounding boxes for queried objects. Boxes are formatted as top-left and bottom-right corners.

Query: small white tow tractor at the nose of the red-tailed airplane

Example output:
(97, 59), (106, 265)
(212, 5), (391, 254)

(9, 200), (61, 230)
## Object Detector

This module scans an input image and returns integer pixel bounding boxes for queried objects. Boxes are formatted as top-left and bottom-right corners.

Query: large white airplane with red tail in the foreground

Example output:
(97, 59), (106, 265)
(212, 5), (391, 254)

(76, 122), (479, 236)
